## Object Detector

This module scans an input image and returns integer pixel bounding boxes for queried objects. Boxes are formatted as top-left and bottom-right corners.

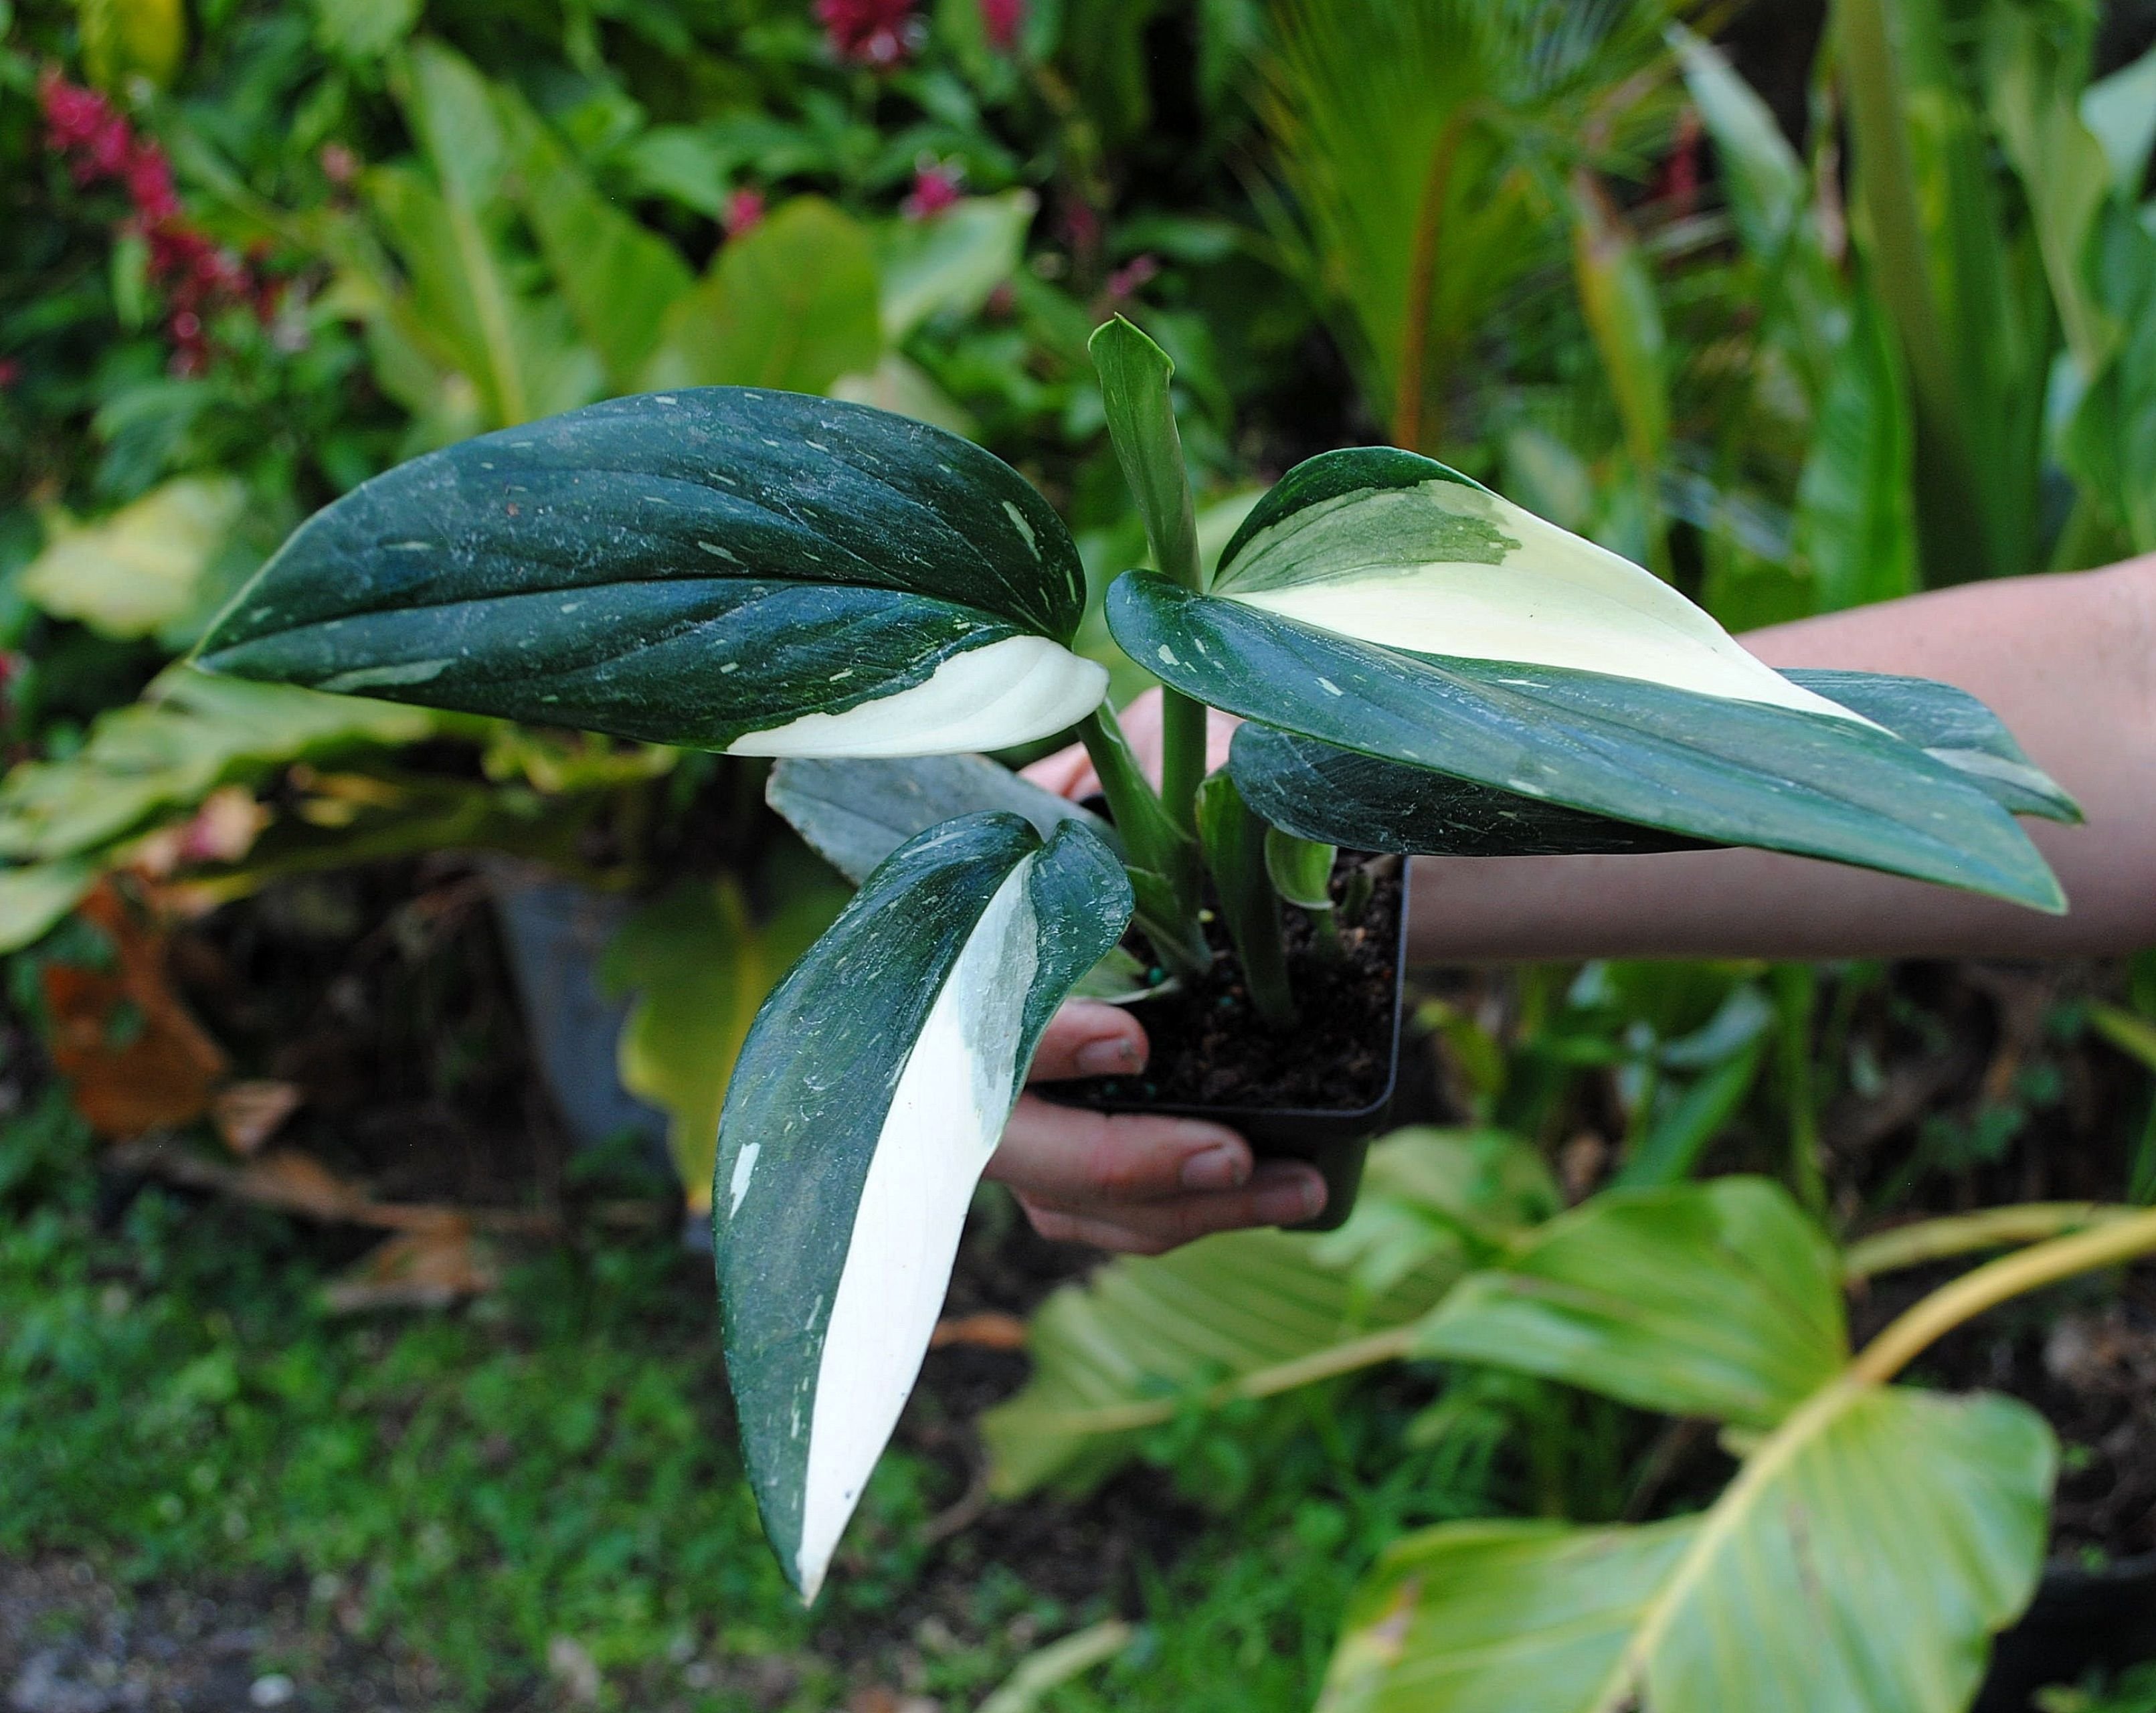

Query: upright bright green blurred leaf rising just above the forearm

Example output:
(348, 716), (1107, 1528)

(1791, 295), (1923, 612)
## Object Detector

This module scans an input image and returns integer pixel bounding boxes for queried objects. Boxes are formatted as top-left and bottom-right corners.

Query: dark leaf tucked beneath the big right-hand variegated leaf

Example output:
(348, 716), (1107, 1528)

(1229, 670), (2080, 855)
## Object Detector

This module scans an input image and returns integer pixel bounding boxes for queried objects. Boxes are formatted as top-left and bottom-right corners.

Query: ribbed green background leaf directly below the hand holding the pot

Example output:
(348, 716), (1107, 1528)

(981, 1129), (1556, 1498)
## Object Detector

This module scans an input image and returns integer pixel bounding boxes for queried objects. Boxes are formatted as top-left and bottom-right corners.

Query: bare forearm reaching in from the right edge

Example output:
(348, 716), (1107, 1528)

(1415, 556), (2156, 963)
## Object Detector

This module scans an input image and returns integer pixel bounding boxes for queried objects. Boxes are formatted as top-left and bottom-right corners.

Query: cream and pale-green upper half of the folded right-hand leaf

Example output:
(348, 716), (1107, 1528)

(1214, 480), (1858, 720)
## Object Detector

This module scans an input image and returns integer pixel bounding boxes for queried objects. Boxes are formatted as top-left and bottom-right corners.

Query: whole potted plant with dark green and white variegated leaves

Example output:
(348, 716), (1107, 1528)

(198, 321), (2074, 1597)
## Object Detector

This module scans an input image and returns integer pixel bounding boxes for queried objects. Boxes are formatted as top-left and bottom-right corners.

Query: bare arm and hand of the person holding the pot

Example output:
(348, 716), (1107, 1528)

(988, 554), (2156, 1254)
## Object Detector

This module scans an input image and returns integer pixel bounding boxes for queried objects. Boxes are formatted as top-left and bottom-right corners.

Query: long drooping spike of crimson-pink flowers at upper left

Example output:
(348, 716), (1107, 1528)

(37, 71), (282, 375)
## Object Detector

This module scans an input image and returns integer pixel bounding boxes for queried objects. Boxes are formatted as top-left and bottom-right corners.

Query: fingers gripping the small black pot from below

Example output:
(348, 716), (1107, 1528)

(988, 1000), (1326, 1254)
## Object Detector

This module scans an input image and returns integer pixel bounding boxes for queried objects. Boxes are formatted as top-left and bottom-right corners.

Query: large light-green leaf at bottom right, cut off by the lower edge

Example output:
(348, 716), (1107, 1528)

(1318, 1387), (2055, 1713)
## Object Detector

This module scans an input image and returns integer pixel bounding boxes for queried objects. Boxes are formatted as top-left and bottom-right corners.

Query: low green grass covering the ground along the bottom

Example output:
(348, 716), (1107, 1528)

(0, 1093), (1484, 1713)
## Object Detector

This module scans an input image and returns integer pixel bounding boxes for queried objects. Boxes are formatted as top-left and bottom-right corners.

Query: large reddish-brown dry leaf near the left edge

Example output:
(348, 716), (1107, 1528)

(43, 881), (226, 1136)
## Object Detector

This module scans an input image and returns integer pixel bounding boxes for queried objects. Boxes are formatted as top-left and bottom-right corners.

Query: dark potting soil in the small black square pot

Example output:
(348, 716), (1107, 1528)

(1043, 851), (1404, 1112)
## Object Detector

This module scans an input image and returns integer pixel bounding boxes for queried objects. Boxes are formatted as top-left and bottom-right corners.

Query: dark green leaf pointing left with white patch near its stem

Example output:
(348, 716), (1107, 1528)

(201, 398), (1106, 756)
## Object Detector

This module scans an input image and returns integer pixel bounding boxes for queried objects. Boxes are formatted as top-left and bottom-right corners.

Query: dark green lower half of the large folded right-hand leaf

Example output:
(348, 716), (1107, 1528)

(1108, 567), (2066, 911)
